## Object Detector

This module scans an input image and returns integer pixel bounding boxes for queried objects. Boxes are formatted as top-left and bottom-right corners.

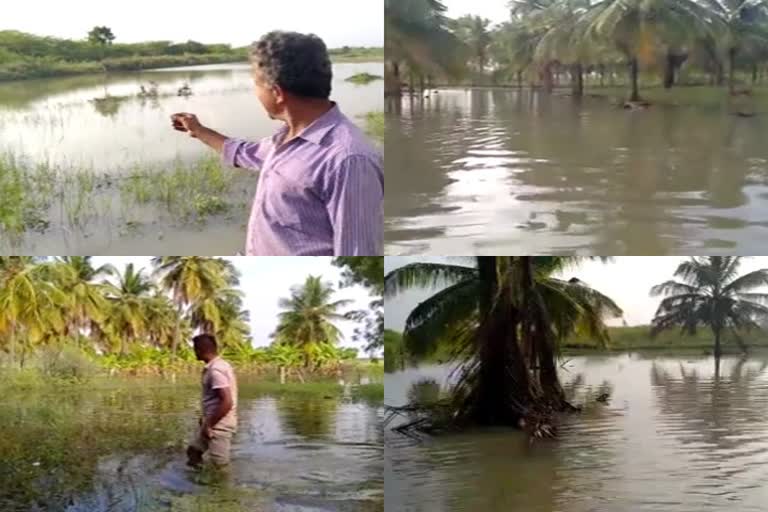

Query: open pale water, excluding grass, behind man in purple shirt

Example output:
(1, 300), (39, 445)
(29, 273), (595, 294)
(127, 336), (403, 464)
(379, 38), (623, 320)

(0, 63), (383, 255)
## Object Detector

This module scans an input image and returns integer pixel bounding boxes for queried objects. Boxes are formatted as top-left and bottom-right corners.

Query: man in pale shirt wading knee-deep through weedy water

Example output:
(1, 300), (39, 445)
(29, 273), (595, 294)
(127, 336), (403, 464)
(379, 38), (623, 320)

(187, 334), (237, 466)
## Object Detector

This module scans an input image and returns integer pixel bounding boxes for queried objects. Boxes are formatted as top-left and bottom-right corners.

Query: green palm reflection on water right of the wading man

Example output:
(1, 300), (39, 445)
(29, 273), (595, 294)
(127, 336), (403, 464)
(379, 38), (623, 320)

(276, 397), (339, 439)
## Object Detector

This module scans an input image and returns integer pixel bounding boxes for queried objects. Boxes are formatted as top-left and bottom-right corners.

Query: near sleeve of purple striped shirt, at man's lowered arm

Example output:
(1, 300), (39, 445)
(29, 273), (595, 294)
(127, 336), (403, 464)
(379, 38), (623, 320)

(326, 155), (384, 256)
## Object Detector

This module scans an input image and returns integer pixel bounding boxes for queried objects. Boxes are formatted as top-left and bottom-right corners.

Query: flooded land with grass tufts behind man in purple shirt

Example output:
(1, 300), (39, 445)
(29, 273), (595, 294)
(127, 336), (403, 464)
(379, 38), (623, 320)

(0, 63), (383, 255)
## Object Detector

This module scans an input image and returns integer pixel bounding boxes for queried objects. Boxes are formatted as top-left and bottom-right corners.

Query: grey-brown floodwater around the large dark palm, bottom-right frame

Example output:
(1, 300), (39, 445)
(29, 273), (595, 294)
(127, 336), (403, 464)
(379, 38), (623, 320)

(385, 355), (768, 512)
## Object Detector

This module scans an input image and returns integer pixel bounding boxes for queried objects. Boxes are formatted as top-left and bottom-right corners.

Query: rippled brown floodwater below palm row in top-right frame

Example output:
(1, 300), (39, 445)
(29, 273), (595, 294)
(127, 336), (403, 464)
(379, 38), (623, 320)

(385, 89), (768, 255)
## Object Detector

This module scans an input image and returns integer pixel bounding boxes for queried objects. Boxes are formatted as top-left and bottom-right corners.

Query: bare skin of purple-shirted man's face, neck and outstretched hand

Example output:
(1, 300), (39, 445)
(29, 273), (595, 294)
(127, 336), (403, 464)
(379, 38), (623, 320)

(171, 67), (333, 153)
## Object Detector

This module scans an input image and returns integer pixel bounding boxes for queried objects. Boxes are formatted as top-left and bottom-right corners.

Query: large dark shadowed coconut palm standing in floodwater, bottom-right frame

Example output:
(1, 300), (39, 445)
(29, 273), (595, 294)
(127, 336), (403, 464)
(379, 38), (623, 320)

(385, 256), (621, 425)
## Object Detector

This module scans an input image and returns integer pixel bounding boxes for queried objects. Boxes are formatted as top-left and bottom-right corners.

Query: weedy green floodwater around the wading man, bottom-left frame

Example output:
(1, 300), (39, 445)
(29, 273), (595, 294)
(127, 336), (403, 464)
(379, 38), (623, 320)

(0, 379), (384, 512)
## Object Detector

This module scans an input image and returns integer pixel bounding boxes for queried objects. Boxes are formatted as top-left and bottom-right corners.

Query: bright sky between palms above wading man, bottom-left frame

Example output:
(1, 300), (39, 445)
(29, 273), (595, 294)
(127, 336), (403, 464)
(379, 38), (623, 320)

(92, 256), (371, 356)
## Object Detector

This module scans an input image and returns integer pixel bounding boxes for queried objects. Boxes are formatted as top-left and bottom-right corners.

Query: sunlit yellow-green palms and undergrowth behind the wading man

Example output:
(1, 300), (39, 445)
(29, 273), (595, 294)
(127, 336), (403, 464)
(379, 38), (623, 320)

(0, 256), (383, 372)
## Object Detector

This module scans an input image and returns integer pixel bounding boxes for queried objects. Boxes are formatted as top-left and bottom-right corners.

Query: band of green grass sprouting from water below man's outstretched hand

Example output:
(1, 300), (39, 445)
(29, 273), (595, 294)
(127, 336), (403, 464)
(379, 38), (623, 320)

(0, 153), (253, 238)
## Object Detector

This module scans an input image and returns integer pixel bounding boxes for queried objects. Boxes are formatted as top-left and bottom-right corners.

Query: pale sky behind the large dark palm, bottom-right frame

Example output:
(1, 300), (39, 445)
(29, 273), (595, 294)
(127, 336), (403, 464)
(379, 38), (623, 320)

(384, 256), (768, 331)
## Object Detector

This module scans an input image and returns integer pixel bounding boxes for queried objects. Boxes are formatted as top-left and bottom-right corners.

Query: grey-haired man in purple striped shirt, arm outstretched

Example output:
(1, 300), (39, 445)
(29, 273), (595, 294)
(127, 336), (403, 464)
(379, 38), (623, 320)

(172, 32), (384, 256)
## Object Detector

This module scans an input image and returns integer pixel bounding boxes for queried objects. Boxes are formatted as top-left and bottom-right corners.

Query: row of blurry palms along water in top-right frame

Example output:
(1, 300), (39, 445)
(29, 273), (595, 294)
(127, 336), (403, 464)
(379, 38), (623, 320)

(385, 0), (768, 102)
